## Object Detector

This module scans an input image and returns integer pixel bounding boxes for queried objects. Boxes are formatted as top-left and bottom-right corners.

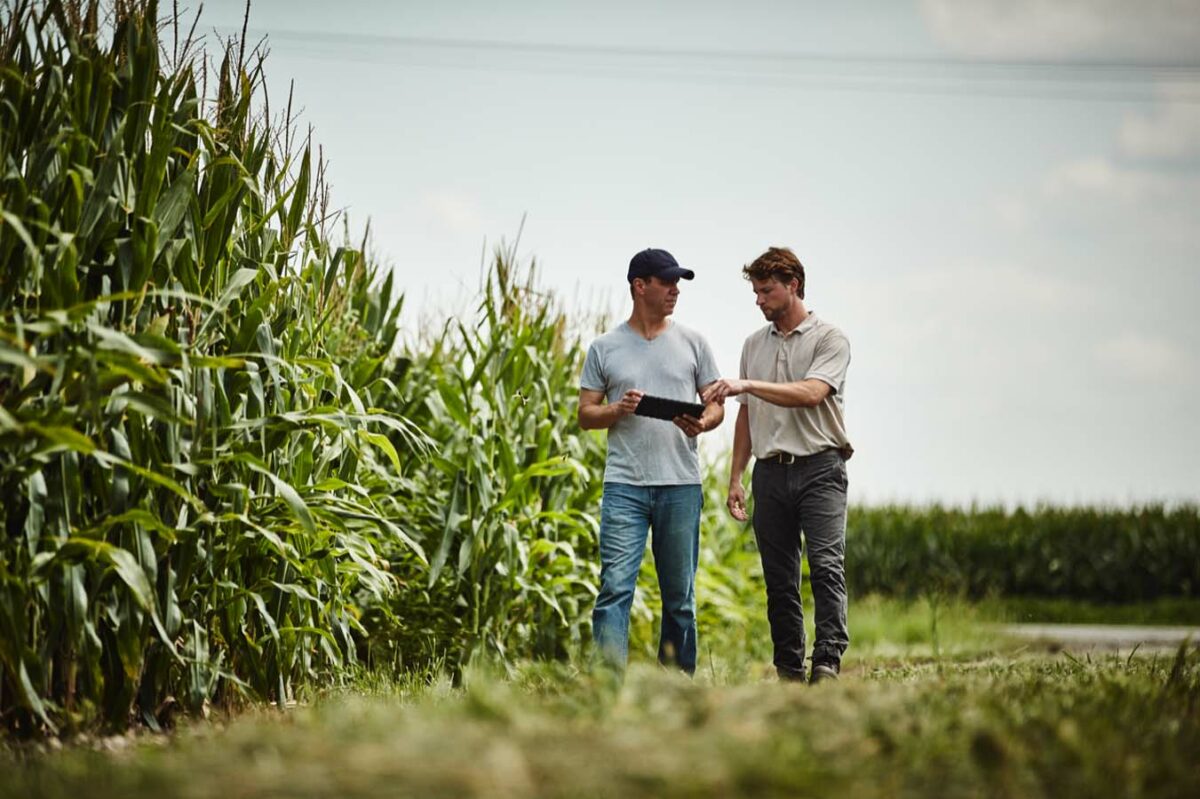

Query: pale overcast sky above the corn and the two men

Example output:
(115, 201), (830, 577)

(200, 0), (1200, 505)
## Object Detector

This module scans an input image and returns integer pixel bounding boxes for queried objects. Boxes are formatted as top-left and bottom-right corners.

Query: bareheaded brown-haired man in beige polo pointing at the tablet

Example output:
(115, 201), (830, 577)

(703, 247), (853, 683)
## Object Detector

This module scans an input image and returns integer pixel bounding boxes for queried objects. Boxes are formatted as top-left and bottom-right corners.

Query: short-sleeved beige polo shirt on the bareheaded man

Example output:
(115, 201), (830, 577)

(738, 312), (854, 458)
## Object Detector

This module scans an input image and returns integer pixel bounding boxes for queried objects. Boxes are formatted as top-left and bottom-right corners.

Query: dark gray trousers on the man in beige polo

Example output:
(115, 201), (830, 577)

(751, 450), (850, 678)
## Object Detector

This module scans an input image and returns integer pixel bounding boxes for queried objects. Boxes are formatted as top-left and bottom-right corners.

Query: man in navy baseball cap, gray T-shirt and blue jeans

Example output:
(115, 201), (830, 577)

(578, 250), (725, 674)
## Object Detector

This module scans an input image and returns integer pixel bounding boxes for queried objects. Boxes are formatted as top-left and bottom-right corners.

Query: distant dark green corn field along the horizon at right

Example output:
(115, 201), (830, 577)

(846, 505), (1200, 602)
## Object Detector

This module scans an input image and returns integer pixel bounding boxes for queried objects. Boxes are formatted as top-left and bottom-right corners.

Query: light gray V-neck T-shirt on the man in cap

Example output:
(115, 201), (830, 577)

(580, 322), (720, 486)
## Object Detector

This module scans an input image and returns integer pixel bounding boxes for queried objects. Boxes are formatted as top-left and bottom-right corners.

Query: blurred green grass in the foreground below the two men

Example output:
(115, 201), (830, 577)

(0, 599), (1200, 799)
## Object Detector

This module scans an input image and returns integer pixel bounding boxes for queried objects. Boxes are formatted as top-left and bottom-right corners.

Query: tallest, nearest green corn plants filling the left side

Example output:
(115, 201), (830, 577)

(0, 0), (426, 733)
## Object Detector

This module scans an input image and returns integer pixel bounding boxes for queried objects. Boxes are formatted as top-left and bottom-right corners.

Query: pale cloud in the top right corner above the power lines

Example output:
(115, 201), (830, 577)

(919, 0), (1200, 64)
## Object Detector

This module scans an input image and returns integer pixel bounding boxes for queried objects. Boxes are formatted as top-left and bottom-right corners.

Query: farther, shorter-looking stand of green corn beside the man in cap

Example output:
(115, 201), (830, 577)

(371, 247), (605, 667)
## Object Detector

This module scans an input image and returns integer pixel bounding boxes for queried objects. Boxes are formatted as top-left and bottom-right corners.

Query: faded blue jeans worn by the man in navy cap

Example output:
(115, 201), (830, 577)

(592, 482), (704, 674)
